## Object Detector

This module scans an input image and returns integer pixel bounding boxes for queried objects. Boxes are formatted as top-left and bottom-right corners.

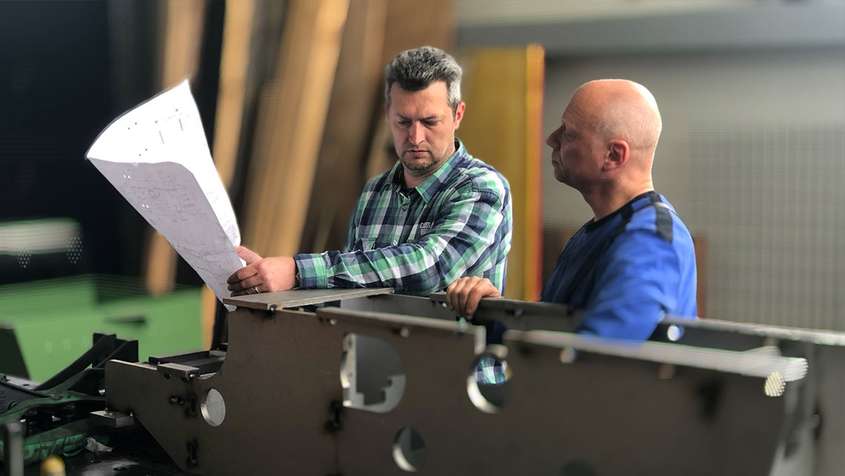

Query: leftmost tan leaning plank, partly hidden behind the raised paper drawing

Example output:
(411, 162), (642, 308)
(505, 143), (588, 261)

(144, 0), (206, 295)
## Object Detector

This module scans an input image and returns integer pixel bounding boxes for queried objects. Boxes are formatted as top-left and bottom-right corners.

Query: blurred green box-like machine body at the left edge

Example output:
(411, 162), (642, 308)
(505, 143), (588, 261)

(0, 275), (202, 381)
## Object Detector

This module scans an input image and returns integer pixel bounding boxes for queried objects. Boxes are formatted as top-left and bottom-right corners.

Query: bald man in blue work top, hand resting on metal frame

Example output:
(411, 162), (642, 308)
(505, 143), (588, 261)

(447, 79), (696, 340)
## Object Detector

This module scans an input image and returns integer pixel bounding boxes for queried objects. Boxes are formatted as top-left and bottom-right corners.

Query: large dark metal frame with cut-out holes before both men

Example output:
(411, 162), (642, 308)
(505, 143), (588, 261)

(106, 290), (806, 476)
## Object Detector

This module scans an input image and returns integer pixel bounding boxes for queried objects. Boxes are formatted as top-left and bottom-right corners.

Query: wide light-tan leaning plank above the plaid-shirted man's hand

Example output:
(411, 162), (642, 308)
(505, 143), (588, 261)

(244, 0), (349, 255)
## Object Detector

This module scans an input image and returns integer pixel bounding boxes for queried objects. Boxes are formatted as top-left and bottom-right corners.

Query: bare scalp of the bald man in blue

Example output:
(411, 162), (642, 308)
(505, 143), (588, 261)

(569, 79), (663, 158)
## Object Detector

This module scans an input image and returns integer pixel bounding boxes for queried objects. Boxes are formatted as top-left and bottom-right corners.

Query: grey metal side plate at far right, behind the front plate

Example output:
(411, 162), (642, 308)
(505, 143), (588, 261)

(653, 318), (845, 476)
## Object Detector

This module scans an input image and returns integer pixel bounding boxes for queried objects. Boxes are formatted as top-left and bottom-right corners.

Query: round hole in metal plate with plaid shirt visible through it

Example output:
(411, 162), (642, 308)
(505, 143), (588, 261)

(467, 353), (513, 413)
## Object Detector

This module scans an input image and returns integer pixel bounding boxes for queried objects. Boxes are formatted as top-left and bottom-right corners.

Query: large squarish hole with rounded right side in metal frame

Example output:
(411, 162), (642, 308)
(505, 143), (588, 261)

(340, 334), (406, 413)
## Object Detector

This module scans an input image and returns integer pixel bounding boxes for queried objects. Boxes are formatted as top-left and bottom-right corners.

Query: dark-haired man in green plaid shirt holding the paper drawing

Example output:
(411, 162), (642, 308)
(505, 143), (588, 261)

(229, 46), (511, 295)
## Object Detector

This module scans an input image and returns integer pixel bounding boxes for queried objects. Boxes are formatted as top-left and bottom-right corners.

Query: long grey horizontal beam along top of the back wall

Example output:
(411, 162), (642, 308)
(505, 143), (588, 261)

(458, 2), (845, 57)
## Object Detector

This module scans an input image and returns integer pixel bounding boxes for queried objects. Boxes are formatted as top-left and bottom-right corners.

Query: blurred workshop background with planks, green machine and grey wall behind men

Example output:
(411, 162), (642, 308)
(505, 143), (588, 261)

(0, 0), (845, 380)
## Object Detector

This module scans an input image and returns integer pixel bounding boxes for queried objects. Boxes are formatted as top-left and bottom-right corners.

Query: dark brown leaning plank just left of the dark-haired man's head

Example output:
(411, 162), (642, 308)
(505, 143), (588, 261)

(301, 0), (387, 251)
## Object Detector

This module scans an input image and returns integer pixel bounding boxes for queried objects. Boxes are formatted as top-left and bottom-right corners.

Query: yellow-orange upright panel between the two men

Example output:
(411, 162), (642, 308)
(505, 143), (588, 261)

(459, 45), (544, 300)
